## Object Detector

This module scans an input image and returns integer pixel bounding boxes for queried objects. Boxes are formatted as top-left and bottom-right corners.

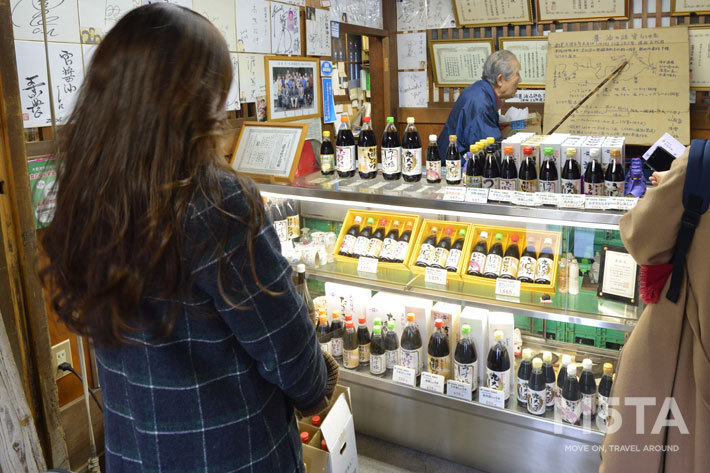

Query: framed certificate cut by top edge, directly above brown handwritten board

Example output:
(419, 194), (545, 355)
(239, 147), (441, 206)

(536, 0), (629, 23)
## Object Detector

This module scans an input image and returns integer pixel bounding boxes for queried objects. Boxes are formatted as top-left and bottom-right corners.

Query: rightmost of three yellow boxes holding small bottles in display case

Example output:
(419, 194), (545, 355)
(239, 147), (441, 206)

(461, 225), (562, 294)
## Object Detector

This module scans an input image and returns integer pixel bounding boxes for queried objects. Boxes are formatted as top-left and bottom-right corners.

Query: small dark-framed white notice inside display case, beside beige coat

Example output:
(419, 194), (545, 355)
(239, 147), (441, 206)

(597, 245), (639, 305)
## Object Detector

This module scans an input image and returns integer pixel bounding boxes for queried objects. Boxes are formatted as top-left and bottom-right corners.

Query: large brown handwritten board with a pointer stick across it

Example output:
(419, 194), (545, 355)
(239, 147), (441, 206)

(544, 26), (690, 146)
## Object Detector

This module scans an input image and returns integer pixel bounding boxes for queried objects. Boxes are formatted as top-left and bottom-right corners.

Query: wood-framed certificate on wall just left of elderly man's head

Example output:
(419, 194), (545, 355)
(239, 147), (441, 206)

(429, 38), (495, 87)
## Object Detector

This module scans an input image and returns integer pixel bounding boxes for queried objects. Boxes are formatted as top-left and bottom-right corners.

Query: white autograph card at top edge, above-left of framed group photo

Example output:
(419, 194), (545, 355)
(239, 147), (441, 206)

(237, 0), (271, 53)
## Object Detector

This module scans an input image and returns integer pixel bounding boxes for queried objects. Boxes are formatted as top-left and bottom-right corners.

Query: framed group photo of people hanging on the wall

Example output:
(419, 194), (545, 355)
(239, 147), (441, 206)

(264, 56), (321, 121)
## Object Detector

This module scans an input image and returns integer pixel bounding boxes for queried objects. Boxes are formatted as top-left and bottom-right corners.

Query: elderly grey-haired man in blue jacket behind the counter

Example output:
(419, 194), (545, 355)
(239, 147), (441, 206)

(437, 50), (520, 159)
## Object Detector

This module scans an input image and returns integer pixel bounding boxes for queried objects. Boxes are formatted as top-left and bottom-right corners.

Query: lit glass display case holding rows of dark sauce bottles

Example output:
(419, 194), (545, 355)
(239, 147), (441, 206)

(260, 173), (643, 472)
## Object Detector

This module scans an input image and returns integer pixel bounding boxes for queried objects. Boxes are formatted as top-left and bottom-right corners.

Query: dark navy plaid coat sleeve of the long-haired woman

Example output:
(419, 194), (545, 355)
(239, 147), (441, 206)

(188, 178), (327, 409)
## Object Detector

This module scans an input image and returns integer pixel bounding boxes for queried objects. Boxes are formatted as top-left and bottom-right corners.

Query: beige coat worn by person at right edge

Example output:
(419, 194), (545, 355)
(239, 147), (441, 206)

(599, 152), (710, 473)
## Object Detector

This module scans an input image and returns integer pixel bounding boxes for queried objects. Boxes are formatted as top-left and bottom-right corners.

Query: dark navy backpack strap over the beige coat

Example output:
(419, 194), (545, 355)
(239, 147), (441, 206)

(666, 140), (710, 302)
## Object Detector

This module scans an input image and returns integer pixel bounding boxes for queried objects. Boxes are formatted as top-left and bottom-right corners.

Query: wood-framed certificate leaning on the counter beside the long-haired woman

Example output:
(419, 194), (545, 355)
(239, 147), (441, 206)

(229, 121), (308, 184)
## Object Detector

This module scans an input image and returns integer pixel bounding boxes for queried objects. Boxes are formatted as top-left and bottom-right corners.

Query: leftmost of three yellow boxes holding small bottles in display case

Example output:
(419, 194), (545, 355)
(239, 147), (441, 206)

(333, 209), (421, 269)
